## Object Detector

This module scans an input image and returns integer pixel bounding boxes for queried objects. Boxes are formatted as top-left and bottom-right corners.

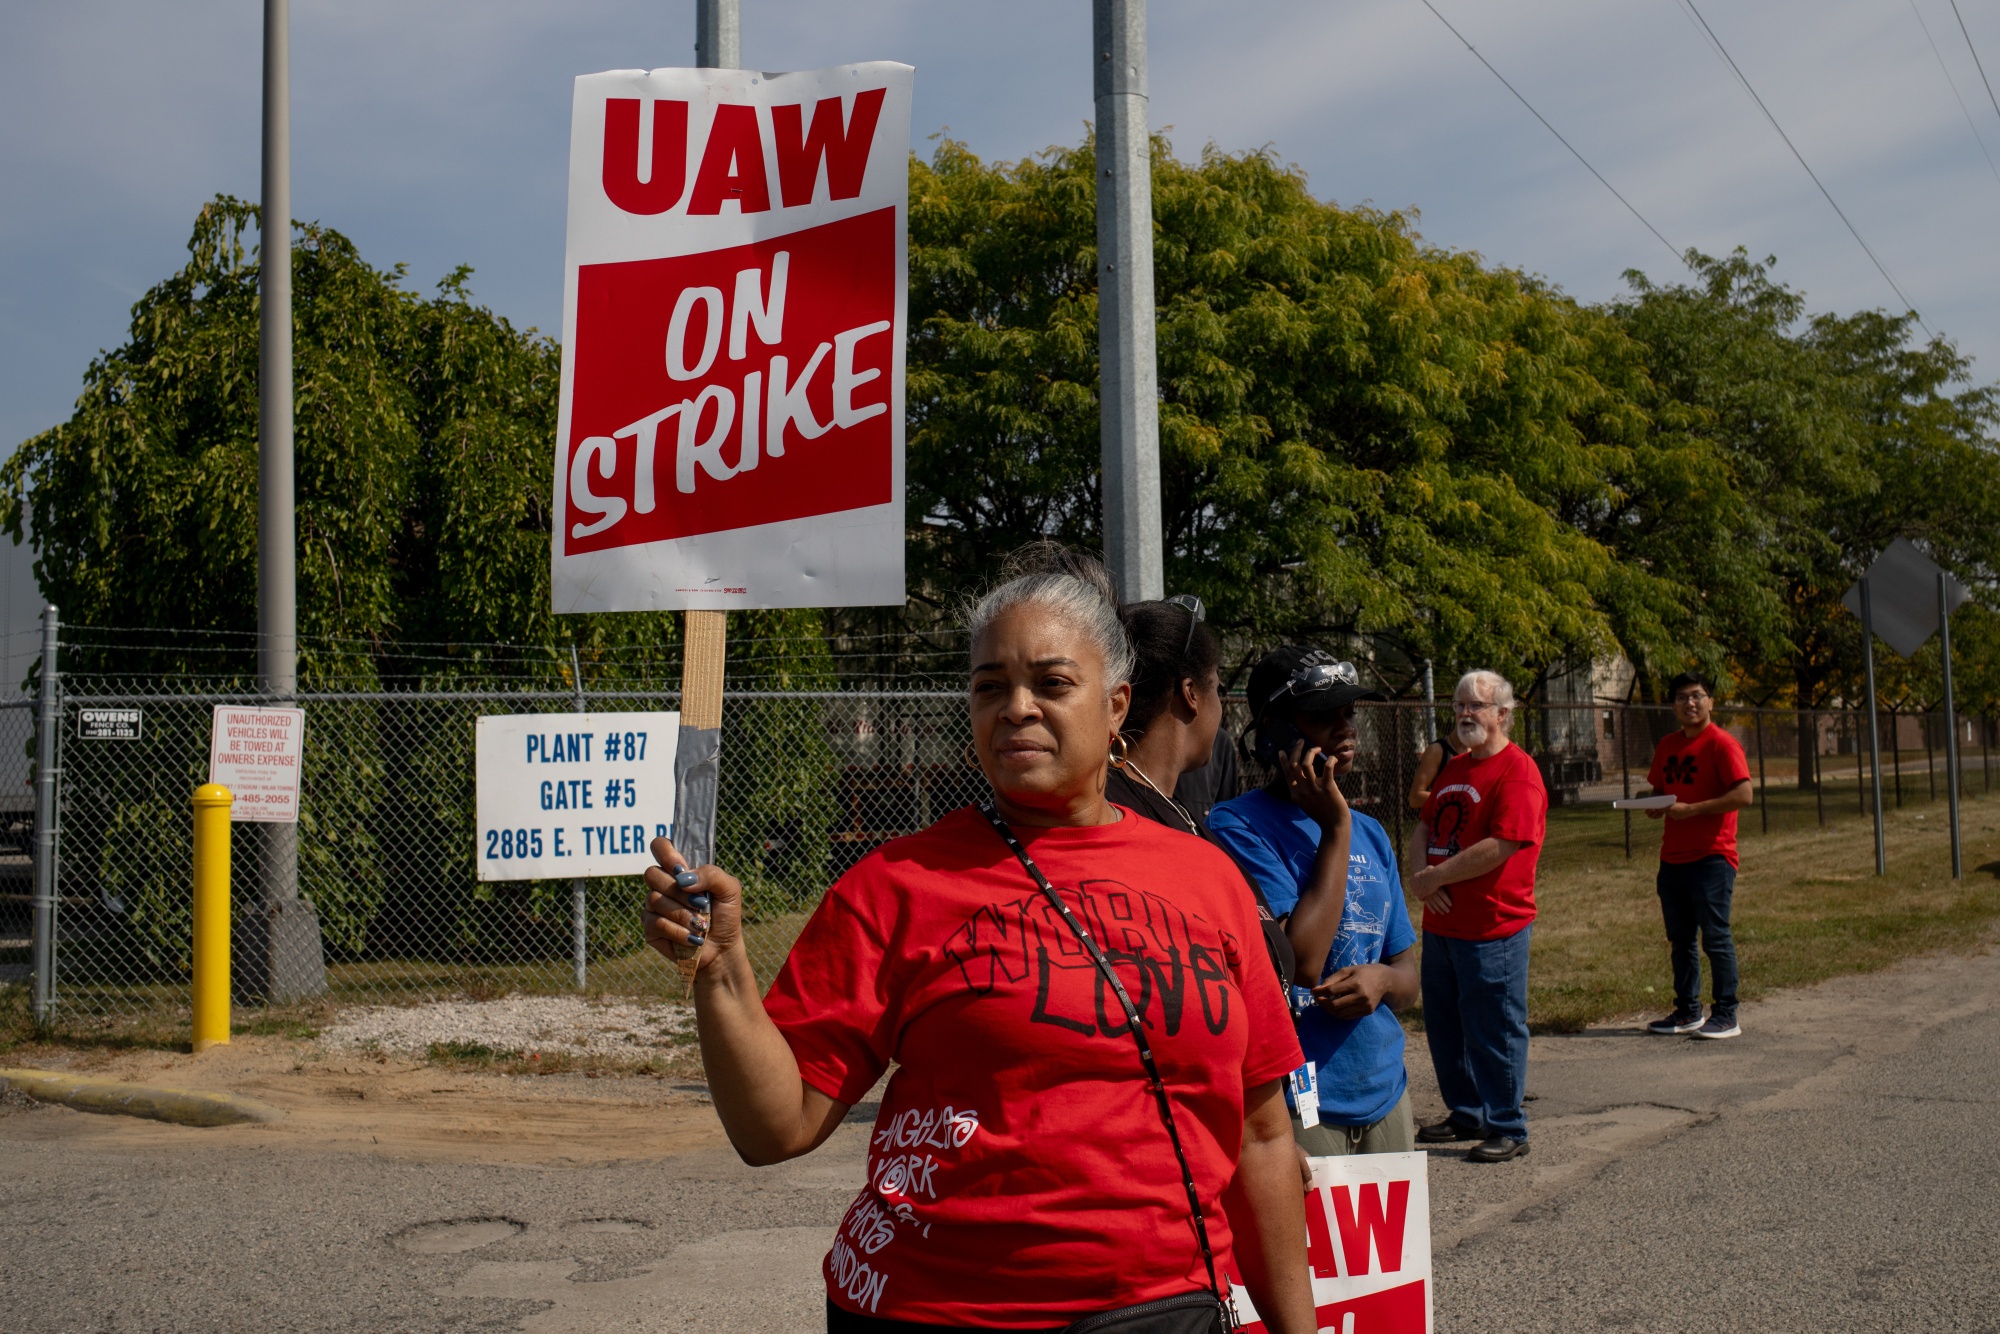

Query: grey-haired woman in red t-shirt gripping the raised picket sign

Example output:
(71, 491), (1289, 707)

(646, 544), (1314, 1334)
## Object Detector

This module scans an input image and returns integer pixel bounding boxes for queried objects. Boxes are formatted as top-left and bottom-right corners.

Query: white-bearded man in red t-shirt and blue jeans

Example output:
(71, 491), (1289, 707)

(1406, 672), (1548, 1162)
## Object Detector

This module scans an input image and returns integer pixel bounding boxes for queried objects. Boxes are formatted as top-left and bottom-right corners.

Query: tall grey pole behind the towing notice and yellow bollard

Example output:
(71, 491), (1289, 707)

(260, 0), (326, 1000)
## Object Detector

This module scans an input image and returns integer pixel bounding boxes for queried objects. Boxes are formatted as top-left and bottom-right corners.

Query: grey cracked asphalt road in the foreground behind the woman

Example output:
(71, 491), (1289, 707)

(0, 954), (2000, 1334)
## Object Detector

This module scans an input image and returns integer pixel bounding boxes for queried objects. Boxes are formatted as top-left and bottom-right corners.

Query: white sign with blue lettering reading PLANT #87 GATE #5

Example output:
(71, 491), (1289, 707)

(476, 714), (680, 880)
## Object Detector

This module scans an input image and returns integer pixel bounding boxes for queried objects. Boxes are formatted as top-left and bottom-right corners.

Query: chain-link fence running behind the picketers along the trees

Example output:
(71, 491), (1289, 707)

(0, 640), (1994, 1016)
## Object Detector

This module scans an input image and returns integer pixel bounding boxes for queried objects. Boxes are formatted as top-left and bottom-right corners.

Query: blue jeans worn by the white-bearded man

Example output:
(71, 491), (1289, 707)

(1424, 926), (1534, 1140)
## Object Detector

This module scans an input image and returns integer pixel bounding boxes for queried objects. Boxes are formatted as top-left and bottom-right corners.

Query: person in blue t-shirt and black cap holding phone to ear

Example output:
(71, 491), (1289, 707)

(1208, 644), (1418, 1154)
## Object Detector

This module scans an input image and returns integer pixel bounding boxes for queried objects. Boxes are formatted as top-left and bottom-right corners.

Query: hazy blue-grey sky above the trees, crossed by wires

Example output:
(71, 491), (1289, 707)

(0, 0), (2000, 448)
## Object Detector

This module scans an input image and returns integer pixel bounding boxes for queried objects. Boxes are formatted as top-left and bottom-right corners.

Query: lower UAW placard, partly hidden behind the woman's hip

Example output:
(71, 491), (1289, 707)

(1232, 1154), (1430, 1334)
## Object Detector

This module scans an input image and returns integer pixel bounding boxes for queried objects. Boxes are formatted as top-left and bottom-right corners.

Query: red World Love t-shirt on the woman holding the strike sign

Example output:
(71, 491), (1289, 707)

(764, 808), (1304, 1328)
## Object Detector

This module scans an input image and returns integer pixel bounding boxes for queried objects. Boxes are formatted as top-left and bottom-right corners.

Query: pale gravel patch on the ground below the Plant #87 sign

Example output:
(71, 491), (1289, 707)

(320, 996), (694, 1056)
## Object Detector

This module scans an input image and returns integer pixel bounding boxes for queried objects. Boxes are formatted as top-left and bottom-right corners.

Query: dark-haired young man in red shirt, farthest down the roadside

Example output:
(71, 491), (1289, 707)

(1646, 672), (1750, 1038)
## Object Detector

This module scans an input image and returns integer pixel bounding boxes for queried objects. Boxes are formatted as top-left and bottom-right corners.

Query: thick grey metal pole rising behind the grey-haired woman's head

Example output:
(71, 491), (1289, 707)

(1092, 0), (1166, 600)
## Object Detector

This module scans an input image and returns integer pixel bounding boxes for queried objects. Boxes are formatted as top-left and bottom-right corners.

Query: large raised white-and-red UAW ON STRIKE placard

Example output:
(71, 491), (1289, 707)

(554, 64), (912, 612)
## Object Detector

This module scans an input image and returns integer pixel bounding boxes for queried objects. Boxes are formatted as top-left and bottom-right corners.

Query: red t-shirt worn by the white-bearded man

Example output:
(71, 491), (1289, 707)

(1422, 742), (1548, 940)
